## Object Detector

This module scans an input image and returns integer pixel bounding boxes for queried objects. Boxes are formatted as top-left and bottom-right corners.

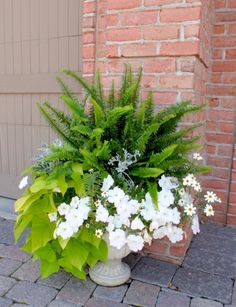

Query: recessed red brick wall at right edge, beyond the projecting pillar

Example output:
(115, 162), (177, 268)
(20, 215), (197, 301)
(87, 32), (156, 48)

(206, 0), (236, 225)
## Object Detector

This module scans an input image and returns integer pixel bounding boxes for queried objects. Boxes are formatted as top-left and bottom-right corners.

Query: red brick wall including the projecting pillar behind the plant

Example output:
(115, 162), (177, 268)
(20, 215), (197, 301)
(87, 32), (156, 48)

(83, 0), (236, 263)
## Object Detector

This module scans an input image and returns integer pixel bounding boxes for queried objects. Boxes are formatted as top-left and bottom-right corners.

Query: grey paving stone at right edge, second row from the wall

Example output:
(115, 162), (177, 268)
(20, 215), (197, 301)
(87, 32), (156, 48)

(191, 233), (236, 257)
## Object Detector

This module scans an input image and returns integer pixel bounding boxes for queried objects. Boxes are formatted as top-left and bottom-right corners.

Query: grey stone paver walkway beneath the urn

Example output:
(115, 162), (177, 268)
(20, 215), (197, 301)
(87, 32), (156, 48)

(0, 219), (236, 307)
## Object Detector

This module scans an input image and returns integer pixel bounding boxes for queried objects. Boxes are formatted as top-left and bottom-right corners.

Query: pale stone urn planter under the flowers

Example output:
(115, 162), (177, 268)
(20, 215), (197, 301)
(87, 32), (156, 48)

(89, 234), (131, 287)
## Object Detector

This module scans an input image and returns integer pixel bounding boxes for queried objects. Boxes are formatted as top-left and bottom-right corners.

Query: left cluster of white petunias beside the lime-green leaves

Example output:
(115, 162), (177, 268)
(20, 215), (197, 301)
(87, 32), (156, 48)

(48, 196), (91, 240)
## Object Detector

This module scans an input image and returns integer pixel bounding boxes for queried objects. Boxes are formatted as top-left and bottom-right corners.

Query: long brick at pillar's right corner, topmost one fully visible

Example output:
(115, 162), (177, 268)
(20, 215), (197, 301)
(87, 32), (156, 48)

(160, 7), (201, 22)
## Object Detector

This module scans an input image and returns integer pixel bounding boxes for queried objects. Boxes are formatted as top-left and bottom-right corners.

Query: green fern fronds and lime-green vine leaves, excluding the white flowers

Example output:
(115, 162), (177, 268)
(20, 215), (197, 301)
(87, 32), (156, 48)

(15, 65), (208, 279)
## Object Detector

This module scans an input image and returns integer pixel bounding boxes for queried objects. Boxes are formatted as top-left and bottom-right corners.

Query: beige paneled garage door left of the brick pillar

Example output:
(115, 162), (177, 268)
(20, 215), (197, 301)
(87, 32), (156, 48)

(0, 0), (82, 198)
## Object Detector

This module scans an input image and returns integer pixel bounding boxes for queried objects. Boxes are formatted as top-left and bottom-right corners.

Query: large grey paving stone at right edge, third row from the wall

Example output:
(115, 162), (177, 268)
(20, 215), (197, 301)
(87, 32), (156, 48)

(183, 248), (236, 278)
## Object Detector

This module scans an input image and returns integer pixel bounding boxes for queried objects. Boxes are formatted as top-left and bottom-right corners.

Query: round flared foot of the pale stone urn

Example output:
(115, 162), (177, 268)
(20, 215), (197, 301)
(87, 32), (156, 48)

(89, 259), (130, 287)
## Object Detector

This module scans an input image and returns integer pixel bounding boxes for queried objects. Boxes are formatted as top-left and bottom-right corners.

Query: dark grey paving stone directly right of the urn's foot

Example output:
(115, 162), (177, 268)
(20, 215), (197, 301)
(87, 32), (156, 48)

(131, 257), (178, 286)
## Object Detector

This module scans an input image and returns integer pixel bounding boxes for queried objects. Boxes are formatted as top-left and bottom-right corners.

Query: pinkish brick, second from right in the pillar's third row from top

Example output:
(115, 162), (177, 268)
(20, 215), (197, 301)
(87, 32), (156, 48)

(143, 26), (179, 40)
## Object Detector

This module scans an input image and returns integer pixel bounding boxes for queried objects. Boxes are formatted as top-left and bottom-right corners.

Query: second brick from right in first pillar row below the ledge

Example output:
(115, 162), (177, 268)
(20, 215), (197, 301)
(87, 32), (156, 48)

(143, 58), (176, 73)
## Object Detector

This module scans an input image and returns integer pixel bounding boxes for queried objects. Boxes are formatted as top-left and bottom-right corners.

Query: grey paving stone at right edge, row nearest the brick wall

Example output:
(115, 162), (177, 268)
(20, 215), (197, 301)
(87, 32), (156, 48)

(200, 223), (236, 241)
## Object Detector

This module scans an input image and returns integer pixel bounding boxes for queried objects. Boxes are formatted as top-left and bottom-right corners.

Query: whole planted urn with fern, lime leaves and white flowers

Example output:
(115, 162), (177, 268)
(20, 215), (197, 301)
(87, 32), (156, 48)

(14, 66), (220, 286)
